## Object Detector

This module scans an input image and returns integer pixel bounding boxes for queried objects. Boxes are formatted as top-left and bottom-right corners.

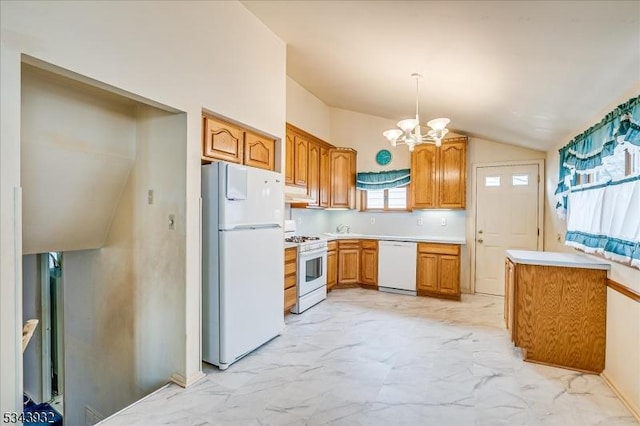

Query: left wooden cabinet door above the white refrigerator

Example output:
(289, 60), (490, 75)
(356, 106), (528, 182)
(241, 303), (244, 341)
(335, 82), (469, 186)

(202, 117), (244, 163)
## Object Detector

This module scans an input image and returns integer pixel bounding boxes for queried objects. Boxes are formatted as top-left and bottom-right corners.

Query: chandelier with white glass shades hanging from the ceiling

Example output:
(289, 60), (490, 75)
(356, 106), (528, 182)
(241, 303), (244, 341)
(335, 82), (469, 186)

(382, 73), (451, 152)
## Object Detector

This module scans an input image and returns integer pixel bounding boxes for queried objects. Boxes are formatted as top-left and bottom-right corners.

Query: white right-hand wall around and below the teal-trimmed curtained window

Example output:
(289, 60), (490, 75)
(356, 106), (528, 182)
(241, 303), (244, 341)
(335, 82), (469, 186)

(544, 86), (640, 416)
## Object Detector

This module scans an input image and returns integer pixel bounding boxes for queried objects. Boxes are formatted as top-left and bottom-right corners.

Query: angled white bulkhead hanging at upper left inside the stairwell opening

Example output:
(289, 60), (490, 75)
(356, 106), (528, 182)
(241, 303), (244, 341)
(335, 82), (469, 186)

(20, 65), (136, 253)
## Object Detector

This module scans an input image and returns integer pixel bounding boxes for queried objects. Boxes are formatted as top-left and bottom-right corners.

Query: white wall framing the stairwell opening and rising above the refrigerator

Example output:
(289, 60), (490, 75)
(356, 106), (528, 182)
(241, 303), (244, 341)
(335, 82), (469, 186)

(0, 1), (286, 411)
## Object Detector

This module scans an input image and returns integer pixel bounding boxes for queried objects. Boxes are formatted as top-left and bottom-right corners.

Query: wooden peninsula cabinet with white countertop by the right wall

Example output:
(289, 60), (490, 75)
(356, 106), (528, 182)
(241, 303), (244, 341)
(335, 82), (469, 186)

(504, 250), (610, 373)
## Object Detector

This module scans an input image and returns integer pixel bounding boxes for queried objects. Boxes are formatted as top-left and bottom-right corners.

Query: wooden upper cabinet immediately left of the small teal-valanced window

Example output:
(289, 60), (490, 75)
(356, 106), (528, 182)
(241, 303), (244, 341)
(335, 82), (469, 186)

(329, 148), (356, 209)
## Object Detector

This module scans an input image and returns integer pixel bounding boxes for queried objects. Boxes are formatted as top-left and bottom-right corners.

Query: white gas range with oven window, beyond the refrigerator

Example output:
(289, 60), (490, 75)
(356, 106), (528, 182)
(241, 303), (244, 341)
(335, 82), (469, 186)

(285, 220), (327, 314)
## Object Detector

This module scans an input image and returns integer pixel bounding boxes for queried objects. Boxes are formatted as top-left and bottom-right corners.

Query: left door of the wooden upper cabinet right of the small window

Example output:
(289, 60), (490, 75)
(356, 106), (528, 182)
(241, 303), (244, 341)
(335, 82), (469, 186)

(411, 144), (440, 209)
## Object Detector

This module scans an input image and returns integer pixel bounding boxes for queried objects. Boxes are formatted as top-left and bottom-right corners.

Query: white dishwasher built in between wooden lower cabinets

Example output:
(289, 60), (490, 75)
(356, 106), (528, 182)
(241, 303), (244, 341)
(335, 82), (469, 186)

(378, 241), (418, 296)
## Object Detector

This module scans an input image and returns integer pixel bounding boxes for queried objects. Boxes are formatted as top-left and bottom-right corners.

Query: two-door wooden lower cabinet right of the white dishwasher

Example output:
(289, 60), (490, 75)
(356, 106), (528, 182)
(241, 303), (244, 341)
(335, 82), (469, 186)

(416, 243), (460, 300)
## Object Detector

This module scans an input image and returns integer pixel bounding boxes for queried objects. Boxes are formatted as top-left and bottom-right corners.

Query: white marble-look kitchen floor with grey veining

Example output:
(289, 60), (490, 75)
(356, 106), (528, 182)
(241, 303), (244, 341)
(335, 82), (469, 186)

(101, 289), (638, 426)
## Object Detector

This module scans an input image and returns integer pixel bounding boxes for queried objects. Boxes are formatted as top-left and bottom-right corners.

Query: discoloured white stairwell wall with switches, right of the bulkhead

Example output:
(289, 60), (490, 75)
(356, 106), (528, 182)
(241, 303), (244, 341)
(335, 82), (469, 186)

(63, 106), (186, 424)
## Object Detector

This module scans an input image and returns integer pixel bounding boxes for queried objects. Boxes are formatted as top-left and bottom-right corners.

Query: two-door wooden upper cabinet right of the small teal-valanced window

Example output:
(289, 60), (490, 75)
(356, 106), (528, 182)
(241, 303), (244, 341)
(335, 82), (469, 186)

(411, 137), (467, 209)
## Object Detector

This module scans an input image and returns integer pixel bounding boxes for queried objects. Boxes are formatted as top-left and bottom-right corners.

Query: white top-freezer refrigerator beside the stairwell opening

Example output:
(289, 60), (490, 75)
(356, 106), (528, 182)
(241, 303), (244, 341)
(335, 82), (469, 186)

(202, 162), (284, 370)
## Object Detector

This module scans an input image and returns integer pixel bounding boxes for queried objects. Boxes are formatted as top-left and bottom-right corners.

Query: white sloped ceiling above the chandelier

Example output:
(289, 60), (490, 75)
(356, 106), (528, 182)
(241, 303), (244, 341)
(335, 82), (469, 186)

(242, 0), (640, 150)
